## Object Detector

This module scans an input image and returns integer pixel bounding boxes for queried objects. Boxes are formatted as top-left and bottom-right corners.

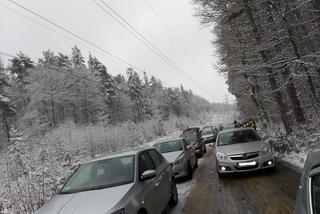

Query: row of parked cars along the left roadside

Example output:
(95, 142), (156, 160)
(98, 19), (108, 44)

(36, 126), (217, 214)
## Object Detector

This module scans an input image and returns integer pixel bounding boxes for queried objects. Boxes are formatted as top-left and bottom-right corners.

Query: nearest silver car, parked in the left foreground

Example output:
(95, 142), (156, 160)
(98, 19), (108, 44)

(36, 148), (178, 214)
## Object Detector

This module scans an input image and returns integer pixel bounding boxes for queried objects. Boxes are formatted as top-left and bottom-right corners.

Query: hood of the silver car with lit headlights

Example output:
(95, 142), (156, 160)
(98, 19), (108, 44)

(216, 141), (266, 155)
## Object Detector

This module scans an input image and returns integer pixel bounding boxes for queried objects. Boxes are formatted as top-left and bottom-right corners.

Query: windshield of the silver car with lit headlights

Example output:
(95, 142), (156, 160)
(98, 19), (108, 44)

(218, 130), (261, 146)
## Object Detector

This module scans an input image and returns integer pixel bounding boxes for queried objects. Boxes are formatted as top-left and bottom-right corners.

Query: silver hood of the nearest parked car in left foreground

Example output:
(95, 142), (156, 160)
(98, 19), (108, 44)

(36, 184), (133, 214)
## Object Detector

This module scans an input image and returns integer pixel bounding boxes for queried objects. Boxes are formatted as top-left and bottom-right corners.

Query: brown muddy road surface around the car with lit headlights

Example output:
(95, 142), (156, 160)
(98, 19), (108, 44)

(182, 147), (300, 214)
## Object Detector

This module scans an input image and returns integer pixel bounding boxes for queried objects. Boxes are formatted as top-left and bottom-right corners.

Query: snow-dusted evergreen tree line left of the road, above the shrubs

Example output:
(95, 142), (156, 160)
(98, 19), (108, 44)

(0, 46), (212, 145)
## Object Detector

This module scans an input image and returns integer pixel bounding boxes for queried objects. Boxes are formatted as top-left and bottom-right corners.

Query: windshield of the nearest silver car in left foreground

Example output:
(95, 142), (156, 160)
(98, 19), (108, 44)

(59, 155), (134, 194)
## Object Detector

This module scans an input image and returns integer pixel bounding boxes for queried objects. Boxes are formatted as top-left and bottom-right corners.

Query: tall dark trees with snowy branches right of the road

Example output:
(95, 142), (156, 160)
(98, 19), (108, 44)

(194, 0), (320, 133)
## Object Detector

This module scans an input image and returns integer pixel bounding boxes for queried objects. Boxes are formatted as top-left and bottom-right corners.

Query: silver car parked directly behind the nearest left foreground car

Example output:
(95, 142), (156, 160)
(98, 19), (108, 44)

(153, 138), (198, 179)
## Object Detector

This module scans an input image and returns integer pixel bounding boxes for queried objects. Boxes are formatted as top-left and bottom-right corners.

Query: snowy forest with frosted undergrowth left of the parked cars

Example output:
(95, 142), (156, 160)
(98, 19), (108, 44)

(0, 46), (233, 213)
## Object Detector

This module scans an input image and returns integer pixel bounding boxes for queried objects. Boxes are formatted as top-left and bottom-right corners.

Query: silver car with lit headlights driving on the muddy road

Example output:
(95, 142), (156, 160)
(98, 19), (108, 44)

(215, 128), (275, 176)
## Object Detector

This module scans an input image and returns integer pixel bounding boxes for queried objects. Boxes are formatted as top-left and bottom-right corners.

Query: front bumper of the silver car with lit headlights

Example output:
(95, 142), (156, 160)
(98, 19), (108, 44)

(216, 153), (275, 173)
